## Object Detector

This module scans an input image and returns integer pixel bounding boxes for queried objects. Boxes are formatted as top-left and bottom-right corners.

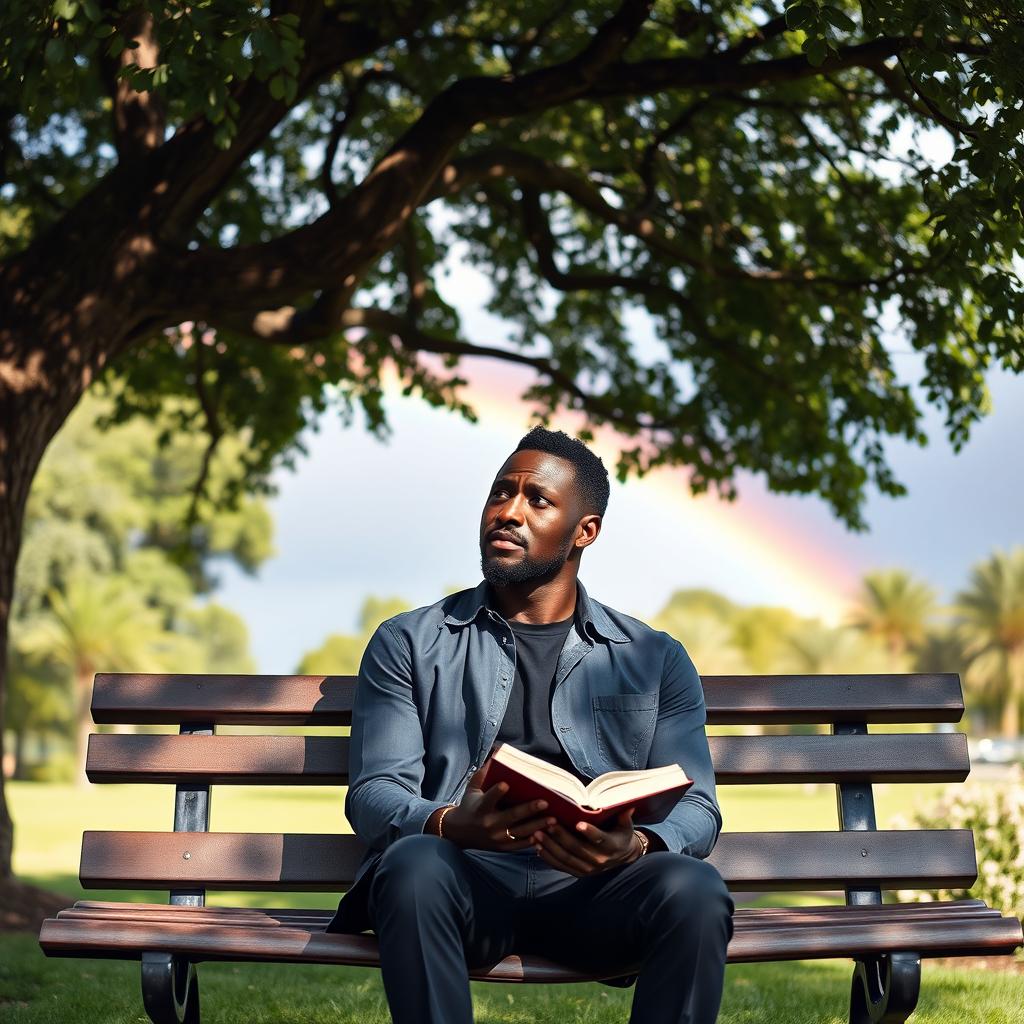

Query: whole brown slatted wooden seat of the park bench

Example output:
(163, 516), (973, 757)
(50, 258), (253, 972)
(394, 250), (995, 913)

(40, 900), (1021, 982)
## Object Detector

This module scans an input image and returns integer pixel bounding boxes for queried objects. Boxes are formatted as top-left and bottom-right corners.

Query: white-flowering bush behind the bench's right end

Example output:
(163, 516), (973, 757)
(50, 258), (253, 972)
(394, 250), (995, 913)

(893, 765), (1024, 918)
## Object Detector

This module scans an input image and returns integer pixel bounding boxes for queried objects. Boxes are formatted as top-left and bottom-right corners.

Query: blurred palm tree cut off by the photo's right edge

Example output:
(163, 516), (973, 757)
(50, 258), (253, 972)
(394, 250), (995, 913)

(955, 547), (1024, 738)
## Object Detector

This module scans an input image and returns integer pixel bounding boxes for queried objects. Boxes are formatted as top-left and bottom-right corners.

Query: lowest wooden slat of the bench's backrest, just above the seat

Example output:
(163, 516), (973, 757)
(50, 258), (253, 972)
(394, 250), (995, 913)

(81, 829), (977, 891)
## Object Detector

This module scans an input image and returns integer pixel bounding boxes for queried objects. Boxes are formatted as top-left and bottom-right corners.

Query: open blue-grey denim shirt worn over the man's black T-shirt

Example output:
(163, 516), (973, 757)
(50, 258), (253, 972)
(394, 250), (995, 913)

(333, 580), (722, 925)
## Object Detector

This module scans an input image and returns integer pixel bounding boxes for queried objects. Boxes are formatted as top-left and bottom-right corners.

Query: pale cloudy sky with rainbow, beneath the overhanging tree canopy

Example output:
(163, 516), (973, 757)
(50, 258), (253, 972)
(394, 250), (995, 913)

(207, 256), (1024, 674)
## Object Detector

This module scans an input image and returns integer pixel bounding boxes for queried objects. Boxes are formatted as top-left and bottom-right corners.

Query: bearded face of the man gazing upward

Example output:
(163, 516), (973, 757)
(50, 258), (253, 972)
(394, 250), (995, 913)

(480, 451), (581, 587)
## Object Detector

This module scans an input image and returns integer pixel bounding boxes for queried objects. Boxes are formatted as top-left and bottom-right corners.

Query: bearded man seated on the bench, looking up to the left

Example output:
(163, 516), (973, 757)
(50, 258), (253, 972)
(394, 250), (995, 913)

(328, 427), (732, 1024)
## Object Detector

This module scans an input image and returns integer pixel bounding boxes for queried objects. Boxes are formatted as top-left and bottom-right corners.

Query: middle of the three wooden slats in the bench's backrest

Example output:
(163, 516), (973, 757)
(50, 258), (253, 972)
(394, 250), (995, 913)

(86, 733), (971, 785)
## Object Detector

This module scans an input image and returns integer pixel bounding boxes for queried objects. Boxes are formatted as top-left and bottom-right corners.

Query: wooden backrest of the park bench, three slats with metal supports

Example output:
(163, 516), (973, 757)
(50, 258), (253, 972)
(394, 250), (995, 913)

(81, 674), (977, 904)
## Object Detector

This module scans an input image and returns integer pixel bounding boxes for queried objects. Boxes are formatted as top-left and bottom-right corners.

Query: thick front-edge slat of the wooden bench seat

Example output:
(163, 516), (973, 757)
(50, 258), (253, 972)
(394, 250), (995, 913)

(40, 911), (1021, 982)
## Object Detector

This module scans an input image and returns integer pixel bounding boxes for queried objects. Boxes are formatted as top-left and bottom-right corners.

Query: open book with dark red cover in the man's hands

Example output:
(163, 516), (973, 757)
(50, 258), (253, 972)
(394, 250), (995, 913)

(481, 743), (693, 828)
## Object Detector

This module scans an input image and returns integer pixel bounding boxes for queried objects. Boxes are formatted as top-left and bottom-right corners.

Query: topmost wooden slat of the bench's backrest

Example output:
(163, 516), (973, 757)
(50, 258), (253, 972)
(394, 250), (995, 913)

(92, 673), (964, 725)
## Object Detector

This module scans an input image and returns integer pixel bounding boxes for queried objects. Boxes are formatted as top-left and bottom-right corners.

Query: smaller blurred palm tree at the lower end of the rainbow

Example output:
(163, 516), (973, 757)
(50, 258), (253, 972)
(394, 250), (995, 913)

(850, 569), (936, 671)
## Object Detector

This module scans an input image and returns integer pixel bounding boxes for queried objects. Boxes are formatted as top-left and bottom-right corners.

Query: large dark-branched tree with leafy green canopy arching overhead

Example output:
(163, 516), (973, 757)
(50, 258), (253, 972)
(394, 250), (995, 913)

(0, 0), (1024, 877)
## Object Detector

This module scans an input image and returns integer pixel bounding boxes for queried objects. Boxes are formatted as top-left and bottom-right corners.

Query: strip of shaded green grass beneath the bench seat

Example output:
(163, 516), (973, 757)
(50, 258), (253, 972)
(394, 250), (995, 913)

(9, 934), (1024, 1024)
